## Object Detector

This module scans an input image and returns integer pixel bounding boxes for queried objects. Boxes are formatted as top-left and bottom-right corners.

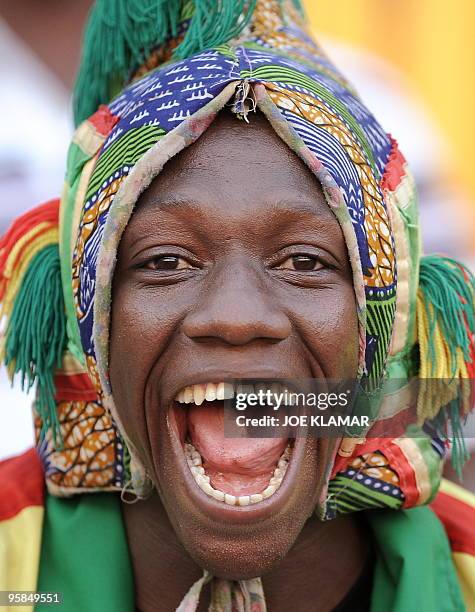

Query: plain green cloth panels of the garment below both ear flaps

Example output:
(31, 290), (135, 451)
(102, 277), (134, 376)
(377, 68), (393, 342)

(38, 493), (465, 612)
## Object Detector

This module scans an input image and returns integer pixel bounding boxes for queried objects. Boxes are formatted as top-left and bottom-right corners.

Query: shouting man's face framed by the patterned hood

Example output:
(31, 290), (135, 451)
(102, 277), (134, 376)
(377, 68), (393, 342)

(110, 113), (358, 578)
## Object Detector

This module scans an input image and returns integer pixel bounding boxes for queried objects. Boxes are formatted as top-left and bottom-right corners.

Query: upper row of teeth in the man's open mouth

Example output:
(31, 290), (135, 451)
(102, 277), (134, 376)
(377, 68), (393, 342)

(175, 382), (289, 406)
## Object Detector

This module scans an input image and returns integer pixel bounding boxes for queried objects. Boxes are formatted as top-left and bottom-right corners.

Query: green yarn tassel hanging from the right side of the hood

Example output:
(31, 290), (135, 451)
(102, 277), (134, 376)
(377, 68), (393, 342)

(419, 255), (475, 479)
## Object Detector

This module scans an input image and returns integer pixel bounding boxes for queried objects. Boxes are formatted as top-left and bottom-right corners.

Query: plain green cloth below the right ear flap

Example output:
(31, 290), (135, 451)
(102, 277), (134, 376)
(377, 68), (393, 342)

(366, 507), (465, 612)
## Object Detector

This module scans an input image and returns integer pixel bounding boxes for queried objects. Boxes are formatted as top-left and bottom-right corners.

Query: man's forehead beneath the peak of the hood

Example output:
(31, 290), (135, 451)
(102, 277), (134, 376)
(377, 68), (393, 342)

(135, 111), (338, 225)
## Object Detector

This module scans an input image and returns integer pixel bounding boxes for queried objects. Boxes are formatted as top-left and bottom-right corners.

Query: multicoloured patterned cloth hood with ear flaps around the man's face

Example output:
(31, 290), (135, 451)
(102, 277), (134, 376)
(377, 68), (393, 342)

(28, 0), (450, 519)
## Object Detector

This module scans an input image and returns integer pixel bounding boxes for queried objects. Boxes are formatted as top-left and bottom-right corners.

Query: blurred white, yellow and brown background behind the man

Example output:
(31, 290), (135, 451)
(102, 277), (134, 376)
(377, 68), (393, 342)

(0, 0), (475, 459)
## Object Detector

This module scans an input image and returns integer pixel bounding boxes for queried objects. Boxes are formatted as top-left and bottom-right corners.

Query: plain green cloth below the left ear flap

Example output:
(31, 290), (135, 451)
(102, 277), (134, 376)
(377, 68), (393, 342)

(37, 493), (135, 612)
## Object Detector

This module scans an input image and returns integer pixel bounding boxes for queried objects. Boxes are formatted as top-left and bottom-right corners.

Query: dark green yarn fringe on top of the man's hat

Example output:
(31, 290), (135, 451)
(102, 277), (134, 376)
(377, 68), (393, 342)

(73, 0), (303, 125)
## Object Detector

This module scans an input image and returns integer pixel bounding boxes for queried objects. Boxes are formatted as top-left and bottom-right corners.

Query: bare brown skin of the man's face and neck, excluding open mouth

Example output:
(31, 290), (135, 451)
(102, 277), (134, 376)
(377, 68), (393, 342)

(110, 112), (367, 612)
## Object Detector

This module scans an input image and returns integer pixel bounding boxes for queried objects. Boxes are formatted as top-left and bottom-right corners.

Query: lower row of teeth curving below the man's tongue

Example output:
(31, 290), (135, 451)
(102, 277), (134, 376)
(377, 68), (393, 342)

(184, 442), (291, 506)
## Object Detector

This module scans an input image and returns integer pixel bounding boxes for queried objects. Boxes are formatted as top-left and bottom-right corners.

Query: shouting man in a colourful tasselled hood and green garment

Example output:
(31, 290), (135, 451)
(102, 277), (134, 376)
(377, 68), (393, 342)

(0, 0), (475, 612)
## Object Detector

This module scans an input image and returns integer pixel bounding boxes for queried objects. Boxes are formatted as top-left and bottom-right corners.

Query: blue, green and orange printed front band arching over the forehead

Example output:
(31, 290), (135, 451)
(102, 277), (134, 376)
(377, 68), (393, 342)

(73, 38), (395, 380)
